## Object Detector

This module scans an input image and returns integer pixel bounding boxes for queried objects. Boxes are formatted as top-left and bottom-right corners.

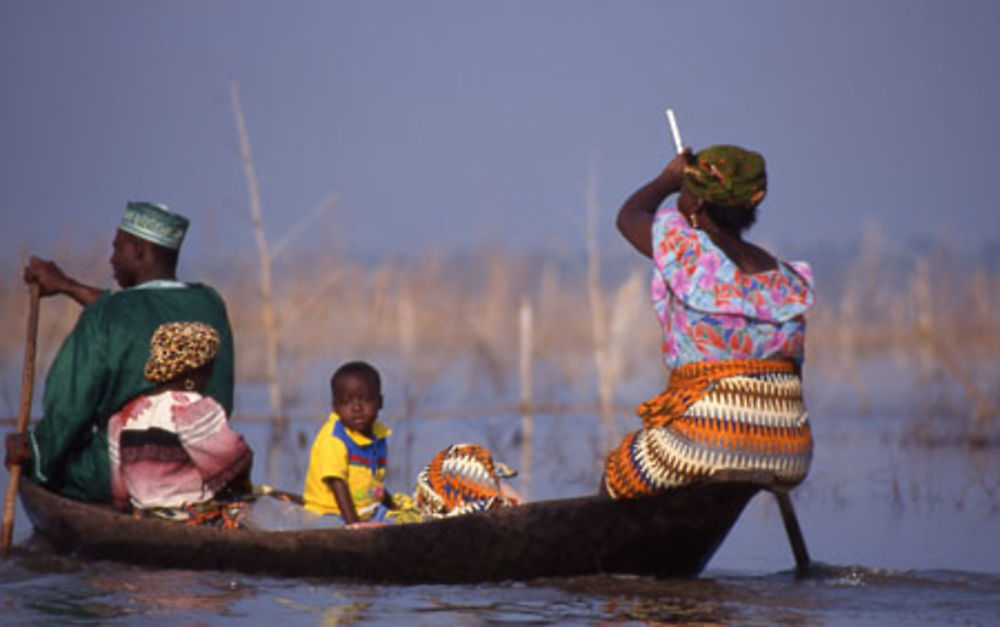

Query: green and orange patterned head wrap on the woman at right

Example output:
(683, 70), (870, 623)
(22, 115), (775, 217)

(684, 146), (767, 210)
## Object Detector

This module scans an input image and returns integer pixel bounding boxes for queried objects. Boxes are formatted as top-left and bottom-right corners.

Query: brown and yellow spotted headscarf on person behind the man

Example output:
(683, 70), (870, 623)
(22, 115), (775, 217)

(144, 322), (219, 383)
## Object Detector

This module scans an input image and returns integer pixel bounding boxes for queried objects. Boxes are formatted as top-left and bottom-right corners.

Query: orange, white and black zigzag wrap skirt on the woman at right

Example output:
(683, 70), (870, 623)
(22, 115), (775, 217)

(604, 359), (812, 498)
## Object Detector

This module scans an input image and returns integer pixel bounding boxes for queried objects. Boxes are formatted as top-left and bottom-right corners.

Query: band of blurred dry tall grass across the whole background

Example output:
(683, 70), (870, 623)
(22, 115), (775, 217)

(0, 233), (1000, 448)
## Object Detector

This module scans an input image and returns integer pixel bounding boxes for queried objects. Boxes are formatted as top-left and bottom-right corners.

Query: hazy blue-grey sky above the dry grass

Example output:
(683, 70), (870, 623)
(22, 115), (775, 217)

(0, 0), (1000, 272)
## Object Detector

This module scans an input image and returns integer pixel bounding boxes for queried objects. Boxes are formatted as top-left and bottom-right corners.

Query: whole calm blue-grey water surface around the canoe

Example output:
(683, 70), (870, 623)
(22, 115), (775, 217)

(0, 372), (1000, 625)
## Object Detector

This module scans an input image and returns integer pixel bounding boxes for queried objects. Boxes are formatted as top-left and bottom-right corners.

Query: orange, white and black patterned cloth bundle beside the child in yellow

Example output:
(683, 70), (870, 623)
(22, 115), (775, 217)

(414, 444), (517, 518)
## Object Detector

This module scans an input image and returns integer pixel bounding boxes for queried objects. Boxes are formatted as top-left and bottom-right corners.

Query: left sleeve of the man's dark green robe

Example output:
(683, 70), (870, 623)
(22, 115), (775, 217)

(31, 299), (108, 484)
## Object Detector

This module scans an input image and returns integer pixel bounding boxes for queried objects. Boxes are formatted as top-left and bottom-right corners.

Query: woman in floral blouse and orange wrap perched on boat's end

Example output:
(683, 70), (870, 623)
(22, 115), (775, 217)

(602, 146), (813, 498)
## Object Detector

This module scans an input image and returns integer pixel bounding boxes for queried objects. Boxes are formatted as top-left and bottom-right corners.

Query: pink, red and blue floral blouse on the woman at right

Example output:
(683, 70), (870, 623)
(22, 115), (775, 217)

(651, 207), (814, 368)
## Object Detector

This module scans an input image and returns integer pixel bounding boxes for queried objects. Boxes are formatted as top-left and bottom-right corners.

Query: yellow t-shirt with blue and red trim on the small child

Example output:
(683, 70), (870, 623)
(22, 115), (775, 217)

(303, 412), (392, 520)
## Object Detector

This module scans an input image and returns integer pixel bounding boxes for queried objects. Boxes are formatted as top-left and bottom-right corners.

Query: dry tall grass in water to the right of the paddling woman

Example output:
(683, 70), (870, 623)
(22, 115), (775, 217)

(807, 233), (1000, 446)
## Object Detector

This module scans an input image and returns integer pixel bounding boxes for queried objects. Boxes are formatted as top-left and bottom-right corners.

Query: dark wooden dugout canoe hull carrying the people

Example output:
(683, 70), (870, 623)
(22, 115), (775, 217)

(20, 480), (764, 583)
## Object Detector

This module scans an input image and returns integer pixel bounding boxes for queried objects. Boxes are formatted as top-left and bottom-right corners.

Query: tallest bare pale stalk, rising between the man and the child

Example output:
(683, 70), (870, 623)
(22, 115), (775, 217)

(229, 81), (288, 482)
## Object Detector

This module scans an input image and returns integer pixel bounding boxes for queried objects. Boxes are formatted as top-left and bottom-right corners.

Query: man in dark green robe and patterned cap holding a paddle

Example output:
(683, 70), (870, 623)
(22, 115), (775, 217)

(7, 202), (233, 502)
